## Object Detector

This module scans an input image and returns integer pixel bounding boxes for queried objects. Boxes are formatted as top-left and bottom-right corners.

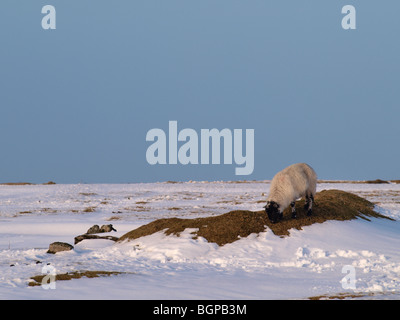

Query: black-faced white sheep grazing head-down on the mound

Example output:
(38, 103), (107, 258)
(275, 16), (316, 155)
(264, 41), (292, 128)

(264, 163), (317, 223)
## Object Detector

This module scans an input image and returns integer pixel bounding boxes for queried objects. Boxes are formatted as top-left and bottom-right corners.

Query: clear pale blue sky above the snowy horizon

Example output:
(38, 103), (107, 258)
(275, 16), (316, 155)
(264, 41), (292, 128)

(0, 0), (400, 183)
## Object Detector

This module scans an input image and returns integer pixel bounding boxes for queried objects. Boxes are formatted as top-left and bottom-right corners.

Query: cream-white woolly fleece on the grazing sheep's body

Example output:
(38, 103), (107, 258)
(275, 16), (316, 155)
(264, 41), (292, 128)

(267, 163), (317, 212)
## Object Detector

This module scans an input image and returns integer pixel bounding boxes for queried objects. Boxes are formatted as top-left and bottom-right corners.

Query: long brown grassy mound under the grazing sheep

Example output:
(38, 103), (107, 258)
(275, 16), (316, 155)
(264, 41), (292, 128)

(118, 190), (390, 246)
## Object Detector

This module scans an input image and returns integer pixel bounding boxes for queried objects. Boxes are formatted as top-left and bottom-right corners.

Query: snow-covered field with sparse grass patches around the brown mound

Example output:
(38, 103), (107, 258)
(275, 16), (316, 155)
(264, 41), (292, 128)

(0, 182), (400, 299)
